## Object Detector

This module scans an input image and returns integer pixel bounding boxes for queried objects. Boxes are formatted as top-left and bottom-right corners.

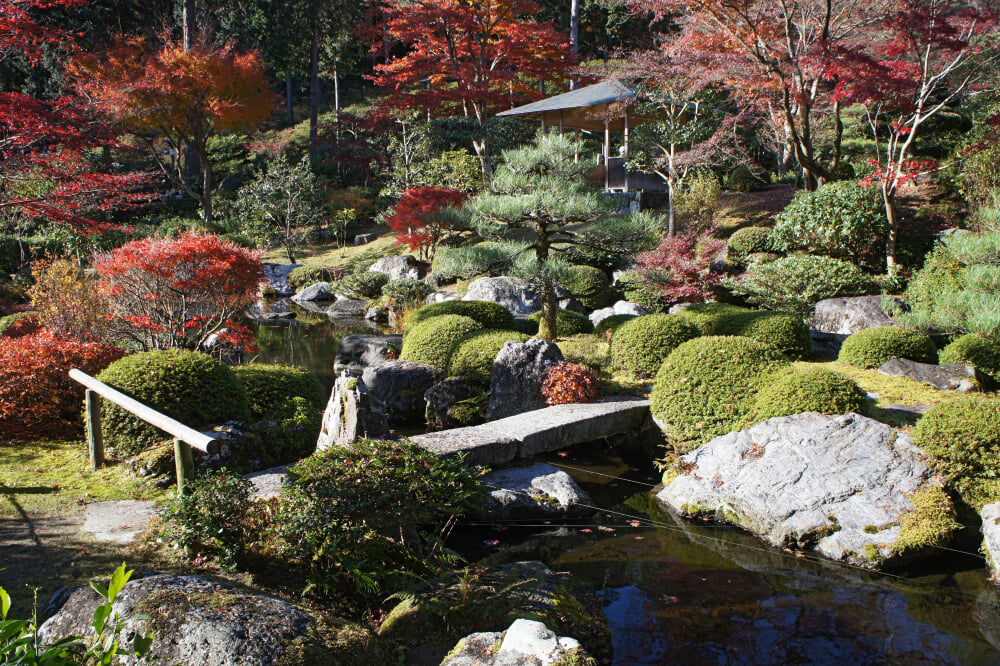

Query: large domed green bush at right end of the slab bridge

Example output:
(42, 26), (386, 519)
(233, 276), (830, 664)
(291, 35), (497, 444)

(650, 336), (788, 451)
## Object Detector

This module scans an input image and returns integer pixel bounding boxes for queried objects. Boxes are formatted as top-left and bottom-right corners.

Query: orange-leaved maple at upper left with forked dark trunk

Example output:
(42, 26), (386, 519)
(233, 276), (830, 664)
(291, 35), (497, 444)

(71, 39), (274, 224)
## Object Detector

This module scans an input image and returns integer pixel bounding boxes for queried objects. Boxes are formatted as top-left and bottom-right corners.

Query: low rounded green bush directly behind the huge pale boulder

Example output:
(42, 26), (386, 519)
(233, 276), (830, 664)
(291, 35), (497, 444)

(746, 368), (867, 426)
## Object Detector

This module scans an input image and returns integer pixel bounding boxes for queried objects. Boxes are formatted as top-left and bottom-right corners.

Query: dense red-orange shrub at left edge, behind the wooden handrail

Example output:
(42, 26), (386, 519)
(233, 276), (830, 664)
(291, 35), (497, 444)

(0, 330), (125, 439)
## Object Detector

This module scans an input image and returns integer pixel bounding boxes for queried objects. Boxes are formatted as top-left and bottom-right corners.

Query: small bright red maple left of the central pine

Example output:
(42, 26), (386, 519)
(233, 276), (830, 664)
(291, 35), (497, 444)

(386, 187), (468, 257)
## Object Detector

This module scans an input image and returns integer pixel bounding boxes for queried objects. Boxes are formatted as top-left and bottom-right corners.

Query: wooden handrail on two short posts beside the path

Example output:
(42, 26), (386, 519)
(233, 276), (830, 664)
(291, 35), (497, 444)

(69, 368), (219, 492)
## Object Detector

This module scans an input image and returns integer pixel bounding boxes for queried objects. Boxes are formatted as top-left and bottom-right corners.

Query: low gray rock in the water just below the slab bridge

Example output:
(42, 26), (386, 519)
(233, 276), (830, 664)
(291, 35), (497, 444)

(477, 463), (594, 519)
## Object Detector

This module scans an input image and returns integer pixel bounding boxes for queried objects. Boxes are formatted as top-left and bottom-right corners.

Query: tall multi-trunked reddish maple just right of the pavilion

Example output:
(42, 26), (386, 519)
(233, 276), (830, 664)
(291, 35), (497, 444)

(629, 0), (893, 189)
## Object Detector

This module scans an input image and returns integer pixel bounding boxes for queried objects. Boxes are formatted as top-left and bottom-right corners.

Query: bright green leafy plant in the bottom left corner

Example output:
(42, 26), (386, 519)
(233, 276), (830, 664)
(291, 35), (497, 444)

(0, 562), (154, 666)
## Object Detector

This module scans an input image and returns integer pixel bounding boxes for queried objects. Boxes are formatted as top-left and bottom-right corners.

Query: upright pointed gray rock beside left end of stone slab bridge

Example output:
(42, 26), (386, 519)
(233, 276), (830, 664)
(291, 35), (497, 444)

(316, 371), (389, 451)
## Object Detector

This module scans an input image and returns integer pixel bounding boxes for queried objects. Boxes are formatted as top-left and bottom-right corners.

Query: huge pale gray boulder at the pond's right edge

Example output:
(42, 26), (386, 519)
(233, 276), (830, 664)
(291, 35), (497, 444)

(657, 412), (931, 568)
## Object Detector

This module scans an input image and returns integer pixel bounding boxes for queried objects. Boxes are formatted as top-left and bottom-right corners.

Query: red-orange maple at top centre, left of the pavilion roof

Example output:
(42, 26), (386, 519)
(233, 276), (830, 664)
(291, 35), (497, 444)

(372, 0), (575, 175)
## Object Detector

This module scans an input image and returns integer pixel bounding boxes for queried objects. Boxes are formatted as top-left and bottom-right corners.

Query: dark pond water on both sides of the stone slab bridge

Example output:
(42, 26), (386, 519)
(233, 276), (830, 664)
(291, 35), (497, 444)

(248, 302), (1000, 666)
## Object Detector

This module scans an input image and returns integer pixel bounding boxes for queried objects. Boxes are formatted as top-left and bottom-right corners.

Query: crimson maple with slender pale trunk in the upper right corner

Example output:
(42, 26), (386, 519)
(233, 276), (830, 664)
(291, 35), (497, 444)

(827, 0), (1000, 270)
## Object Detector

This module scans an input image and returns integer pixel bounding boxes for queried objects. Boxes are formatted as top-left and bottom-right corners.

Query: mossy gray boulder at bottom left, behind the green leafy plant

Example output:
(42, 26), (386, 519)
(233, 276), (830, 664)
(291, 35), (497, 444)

(39, 575), (314, 666)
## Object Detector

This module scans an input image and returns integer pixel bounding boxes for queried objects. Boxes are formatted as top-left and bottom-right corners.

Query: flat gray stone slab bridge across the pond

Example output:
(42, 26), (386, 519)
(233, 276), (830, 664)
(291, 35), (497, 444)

(409, 396), (651, 466)
